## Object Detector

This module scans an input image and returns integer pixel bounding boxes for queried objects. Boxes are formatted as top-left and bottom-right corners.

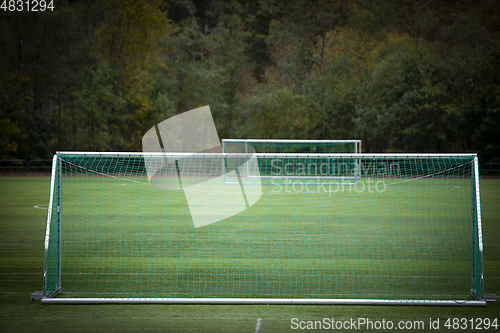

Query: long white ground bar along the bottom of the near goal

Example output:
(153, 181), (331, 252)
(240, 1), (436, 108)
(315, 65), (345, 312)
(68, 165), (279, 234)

(41, 297), (486, 306)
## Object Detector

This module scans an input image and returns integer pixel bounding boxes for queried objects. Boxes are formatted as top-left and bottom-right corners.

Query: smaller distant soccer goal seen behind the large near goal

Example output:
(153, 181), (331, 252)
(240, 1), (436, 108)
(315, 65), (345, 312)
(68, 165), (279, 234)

(222, 139), (361, 185)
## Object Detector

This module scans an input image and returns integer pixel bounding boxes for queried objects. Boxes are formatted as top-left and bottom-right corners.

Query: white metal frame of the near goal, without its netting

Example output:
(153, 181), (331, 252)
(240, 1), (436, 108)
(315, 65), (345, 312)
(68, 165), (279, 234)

(38, 151), (487, 306)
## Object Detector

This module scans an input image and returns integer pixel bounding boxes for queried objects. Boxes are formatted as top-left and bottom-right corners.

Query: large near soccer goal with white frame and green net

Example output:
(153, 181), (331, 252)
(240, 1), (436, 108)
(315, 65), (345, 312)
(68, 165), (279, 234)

(37, 152), (486, 306)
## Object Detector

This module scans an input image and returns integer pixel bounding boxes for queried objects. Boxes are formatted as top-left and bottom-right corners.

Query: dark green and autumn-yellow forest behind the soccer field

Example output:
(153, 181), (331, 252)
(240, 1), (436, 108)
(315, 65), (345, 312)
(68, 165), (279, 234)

(0, 0), (500, 162)
